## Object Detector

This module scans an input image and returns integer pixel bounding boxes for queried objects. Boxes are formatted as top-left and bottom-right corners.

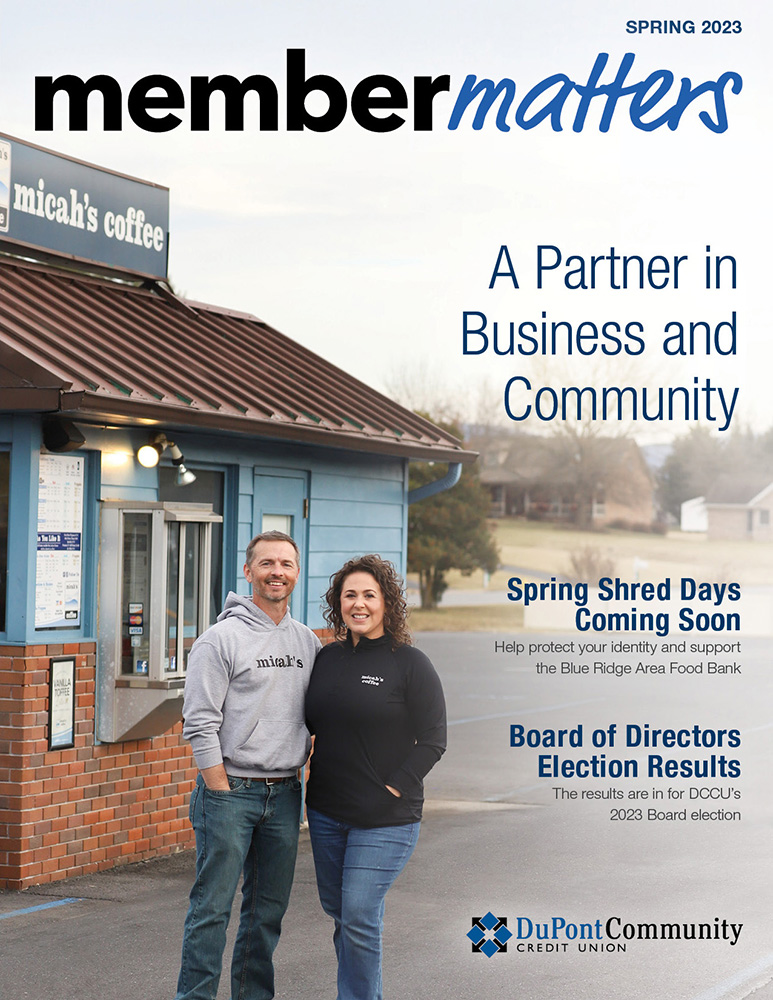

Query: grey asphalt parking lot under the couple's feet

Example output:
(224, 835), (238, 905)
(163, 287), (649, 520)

(0, 634), (773, 1000)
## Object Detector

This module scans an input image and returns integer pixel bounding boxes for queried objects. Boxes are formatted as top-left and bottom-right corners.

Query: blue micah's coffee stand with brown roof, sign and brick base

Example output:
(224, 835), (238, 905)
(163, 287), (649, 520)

(0, 136), (472, 889)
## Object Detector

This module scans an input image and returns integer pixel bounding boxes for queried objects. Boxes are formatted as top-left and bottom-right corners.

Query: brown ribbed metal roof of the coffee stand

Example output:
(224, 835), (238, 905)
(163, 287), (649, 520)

(0, 257), (475, 462)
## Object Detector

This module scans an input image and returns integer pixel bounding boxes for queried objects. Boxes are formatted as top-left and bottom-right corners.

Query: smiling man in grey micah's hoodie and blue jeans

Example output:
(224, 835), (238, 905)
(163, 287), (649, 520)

(176, 531), (320, 1000)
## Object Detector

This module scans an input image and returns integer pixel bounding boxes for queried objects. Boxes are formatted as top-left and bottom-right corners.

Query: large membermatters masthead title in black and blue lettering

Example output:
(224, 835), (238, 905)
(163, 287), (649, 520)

(35, 49), (743, 133)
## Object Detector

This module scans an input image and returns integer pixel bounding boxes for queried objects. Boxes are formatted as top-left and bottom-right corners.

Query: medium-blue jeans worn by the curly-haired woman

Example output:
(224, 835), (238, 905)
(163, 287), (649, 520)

(308, 809), (419, 1000)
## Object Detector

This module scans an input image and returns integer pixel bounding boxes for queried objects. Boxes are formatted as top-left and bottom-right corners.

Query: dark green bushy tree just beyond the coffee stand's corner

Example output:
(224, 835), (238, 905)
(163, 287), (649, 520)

(408, 423), (499, 608)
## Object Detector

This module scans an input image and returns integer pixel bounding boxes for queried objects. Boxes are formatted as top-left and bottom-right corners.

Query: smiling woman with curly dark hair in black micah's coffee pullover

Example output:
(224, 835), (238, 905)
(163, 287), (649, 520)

(306, 555), (446, 1000)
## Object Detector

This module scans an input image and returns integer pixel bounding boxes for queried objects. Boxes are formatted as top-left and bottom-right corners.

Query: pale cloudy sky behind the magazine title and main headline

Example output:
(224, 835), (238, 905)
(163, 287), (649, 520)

(0, 0), (773, 439)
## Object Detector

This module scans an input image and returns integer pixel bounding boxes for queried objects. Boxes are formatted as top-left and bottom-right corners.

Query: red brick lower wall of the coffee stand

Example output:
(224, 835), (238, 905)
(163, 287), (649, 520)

(0, 643), (196, 889)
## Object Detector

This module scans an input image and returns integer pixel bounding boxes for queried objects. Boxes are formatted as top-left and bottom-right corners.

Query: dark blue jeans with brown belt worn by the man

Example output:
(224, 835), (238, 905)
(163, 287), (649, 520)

(176, 775), (301, 1000)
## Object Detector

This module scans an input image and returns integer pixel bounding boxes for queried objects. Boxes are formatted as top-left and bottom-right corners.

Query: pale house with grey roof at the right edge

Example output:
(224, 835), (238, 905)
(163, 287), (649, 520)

(706, 475), (773, 542)
